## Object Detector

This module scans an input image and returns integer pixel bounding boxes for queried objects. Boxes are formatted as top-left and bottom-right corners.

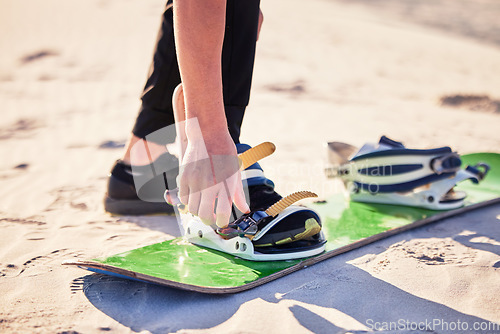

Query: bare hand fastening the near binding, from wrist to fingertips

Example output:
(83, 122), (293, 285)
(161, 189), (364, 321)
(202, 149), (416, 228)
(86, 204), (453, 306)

(179, 124), (250, 227)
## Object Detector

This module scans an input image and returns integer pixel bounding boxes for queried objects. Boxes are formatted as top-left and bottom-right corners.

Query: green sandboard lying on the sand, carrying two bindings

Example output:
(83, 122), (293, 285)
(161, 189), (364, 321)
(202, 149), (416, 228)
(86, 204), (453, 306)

(63, 153), (500, 294)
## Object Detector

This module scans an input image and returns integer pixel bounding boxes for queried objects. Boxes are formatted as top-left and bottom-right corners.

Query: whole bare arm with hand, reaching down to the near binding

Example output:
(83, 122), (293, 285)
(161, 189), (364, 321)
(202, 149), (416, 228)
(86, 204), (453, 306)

(174, 0), (249, 226)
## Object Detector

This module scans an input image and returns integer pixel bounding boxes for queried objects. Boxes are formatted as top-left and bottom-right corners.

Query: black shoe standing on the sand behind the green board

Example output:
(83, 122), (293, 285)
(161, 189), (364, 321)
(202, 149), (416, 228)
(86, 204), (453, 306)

(104, 153), (179, 215)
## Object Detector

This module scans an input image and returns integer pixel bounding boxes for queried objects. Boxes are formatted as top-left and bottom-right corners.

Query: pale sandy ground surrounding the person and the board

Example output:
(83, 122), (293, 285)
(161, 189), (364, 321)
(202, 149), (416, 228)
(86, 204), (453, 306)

(0, 0), (500, 333)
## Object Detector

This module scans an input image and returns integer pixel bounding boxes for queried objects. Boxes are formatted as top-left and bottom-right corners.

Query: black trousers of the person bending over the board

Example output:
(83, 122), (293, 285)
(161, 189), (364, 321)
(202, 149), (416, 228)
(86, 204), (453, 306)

(132, 0), (260, 144)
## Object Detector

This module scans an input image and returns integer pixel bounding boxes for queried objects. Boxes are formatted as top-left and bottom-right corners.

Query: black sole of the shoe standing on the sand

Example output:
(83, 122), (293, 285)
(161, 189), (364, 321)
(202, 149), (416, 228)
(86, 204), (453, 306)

(104, 196), (175, 216)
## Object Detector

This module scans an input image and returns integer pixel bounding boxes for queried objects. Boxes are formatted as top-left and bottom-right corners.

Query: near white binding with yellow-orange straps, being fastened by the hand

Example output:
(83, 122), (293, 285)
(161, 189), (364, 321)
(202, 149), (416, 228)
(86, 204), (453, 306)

(165, 143), (326, 261)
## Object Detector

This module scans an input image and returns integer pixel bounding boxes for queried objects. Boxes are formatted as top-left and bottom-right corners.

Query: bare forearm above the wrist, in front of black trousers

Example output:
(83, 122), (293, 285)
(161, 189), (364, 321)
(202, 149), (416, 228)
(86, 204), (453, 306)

(174, 0), (227, 141)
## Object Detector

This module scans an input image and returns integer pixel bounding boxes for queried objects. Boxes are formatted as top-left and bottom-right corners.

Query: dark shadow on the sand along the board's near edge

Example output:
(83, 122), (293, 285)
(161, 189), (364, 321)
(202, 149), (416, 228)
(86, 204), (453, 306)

(83, 205), (500, 333)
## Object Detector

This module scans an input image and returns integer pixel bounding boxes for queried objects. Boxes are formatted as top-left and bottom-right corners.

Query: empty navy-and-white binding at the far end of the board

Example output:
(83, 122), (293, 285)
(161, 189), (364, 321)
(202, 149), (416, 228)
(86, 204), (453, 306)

(325, 136), (490, 210)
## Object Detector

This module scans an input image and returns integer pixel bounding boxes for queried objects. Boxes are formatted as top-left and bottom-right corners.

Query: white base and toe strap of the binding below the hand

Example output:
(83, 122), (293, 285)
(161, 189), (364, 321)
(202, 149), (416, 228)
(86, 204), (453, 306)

(181, 192), (326, 261)
